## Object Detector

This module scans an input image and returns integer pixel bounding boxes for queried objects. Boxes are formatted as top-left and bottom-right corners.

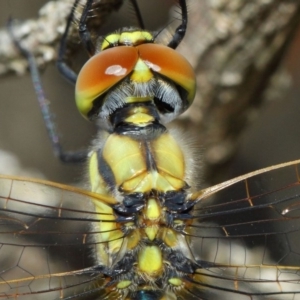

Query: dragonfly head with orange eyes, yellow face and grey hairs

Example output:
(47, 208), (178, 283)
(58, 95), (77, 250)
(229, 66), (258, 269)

(76, 28), (196, 128)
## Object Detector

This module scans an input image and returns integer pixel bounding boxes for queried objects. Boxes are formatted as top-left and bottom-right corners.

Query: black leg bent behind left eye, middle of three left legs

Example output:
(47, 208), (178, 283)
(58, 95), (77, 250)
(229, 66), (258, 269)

(56, 0), (79, 85)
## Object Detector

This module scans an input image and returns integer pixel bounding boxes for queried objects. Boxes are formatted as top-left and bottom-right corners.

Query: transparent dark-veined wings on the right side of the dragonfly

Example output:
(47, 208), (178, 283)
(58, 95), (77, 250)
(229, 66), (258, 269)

(184, 161), (300, 300)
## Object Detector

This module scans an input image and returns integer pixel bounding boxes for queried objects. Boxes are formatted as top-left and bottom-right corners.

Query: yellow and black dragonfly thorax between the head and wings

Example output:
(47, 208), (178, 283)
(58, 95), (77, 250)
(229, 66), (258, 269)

(86, 103), (196, 293)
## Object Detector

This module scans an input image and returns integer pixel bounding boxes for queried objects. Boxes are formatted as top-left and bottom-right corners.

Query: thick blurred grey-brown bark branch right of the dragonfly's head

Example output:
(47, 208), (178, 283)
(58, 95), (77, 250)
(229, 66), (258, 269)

(177, 0), (300, 181)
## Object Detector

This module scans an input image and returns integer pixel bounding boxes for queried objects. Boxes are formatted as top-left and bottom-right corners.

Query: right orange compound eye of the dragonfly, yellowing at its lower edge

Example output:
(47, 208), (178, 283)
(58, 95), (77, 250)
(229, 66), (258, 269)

(136, 44), (196, 105)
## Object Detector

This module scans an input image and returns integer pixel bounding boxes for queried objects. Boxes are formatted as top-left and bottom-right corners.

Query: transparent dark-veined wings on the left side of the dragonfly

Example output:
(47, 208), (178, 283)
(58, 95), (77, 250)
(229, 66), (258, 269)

(0, 177), (117, 299)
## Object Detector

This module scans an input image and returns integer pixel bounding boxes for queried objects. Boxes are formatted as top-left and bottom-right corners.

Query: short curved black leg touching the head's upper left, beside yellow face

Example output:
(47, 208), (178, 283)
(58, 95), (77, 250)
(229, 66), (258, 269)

(79, 0), (95, 56)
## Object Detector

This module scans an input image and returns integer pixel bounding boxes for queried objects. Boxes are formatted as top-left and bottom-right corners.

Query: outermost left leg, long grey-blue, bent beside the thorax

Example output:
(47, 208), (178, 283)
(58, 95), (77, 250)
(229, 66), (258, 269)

(7, 19), (88, 163)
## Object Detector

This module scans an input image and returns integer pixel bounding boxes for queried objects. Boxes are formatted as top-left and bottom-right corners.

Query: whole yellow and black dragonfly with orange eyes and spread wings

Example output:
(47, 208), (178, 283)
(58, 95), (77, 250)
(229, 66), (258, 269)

(0, 0), (300, 300)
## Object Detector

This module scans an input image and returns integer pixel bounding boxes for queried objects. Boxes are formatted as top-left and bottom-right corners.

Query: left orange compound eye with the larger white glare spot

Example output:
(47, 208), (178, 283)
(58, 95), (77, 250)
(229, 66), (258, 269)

(75, 46), (138, 117)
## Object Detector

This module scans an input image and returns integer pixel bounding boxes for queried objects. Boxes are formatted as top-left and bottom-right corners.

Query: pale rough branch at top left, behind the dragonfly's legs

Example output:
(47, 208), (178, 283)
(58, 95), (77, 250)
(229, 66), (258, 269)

(0, 0), (123, 75)
